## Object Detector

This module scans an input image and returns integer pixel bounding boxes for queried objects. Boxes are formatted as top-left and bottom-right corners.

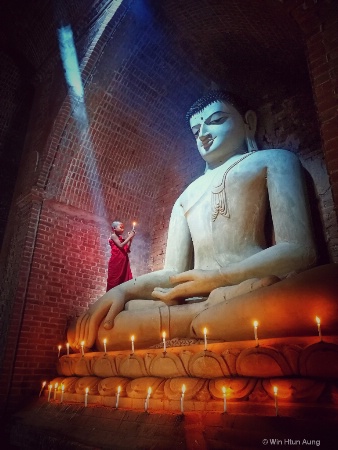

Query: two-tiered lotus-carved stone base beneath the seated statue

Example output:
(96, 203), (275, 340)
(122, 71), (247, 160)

(51, 336), (338, 410)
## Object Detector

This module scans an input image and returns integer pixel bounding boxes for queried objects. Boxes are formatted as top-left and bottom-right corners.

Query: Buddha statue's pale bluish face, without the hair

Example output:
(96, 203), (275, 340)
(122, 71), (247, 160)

(190, 101), (246, 167)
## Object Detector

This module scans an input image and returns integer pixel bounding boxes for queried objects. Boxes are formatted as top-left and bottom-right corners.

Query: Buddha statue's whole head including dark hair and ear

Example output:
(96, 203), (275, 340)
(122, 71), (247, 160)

(186, 91), (257, 167)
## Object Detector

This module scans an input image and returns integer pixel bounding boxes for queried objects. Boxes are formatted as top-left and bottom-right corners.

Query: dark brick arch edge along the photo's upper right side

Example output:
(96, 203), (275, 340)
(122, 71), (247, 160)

(285, 0), (338, 262)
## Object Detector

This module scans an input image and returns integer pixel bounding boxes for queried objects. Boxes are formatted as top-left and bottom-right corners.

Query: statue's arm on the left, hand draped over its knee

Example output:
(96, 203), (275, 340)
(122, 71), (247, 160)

(74, 199), (192, 348)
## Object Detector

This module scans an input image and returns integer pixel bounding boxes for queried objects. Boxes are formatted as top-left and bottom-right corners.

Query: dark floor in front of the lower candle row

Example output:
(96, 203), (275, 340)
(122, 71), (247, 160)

(2, 399), (338, 450)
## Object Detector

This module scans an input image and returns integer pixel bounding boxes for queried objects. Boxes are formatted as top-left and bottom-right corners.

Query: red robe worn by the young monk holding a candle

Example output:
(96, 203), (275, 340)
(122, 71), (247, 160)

(107, 236), (133, 291)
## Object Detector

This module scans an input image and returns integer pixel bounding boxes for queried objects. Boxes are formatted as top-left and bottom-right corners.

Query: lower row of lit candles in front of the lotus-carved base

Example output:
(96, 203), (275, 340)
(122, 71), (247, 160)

(39, 381), (278, 416)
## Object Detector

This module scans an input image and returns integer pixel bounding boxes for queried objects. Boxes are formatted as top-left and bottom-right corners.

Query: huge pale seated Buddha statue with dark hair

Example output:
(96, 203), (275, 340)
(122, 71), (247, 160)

(68, 91), (338, 350)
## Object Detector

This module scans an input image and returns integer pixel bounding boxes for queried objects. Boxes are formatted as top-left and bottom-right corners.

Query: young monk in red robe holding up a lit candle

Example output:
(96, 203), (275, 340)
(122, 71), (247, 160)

(107, 221), (135, 292)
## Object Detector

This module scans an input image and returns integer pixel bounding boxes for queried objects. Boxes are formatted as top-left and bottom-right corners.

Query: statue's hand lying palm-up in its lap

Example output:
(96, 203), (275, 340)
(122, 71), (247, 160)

(152, 269), (225, 305)
